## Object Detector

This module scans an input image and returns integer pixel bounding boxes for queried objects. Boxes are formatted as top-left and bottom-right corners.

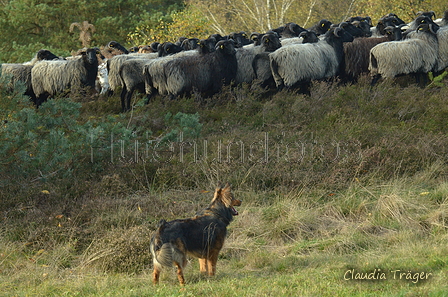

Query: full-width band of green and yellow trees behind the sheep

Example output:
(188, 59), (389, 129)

(0, 0), (447, 63)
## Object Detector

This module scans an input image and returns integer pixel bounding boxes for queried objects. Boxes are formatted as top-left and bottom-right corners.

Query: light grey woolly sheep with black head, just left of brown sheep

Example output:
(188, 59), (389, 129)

(269, 27), (353, 93)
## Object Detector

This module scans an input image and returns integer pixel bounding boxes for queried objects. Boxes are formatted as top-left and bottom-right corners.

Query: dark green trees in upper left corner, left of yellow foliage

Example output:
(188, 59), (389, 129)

(0, 0), (182, 62)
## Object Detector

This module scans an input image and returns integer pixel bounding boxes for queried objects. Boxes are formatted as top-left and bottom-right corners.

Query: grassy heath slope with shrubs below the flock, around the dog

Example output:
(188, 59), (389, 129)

(0, 75), (448, 296)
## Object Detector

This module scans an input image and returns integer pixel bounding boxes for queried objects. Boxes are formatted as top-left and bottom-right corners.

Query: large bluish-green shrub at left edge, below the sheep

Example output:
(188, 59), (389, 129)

(0, 82), (133, 186)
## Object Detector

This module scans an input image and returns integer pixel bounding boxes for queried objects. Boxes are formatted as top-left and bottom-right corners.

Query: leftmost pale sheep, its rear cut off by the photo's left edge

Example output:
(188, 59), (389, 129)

(1, 50), (59, 102)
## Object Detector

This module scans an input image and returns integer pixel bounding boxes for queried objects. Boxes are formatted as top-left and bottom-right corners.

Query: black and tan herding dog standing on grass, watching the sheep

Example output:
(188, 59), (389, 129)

(150, 183), (241, 285)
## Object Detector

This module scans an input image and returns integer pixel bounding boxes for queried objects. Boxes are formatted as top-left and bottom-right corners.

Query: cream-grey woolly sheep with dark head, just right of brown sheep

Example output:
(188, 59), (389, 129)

(369, 23), (438, 85)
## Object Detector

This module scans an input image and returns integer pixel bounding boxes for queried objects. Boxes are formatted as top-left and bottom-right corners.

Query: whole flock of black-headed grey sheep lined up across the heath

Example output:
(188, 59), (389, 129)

(2, 11), (448, 111)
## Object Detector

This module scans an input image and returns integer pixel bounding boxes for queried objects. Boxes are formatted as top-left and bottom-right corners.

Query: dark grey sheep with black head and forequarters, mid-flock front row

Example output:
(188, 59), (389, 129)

(144, 40), (237, 96)
